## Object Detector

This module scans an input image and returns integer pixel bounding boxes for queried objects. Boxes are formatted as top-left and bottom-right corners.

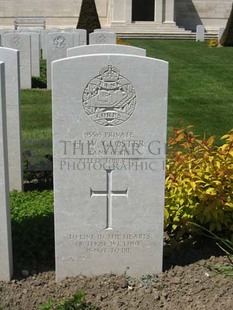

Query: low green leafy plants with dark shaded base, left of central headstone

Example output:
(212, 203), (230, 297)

(10, 191), (54, 269)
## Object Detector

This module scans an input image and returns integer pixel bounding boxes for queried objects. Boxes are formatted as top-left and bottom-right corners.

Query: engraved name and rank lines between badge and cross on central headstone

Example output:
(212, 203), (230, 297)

(59, 132), (166, 171)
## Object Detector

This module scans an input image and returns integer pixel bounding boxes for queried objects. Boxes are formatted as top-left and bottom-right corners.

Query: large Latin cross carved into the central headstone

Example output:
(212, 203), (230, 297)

(90, 170), (128, 230)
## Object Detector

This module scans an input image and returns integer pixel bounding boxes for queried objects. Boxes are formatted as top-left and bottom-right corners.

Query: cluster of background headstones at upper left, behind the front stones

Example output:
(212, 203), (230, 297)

(0, 28), (116, 89)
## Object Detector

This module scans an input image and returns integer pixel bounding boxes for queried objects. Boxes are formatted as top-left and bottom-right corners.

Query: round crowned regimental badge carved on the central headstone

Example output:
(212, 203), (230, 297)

(83, 65), (136, 126)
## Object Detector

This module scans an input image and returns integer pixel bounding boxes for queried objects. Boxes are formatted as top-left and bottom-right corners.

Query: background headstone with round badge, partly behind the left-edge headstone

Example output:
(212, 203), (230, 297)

(3, 33), (32, 89)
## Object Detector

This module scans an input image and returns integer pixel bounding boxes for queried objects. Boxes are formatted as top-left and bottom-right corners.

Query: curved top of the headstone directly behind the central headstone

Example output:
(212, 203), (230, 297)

(67, 44), (146, 57)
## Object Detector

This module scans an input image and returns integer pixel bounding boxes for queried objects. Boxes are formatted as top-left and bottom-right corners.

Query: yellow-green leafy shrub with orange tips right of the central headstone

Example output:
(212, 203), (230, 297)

(165, 126), (233, 238)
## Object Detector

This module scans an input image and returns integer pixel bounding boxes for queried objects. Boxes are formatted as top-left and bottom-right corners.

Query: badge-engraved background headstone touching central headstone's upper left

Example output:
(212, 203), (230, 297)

(47, 32), (74, 89)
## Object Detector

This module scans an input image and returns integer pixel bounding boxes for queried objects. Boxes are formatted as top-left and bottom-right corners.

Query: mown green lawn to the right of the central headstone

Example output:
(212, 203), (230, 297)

(127, 40), (233, 139)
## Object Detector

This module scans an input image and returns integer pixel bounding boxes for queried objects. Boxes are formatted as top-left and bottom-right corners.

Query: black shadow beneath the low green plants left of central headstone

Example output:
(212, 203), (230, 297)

(12, 214), (55, 278)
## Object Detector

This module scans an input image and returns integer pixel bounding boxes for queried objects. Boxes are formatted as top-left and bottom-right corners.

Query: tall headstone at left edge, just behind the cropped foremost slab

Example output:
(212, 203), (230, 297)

(0, 47), (23, 191)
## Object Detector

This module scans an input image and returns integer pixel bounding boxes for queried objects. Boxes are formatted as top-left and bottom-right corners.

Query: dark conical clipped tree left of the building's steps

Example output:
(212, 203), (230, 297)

(76, 0), (101, 34)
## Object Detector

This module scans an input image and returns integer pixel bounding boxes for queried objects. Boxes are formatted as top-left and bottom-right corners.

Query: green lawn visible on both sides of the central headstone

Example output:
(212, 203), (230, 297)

(21, 39), (233, 160)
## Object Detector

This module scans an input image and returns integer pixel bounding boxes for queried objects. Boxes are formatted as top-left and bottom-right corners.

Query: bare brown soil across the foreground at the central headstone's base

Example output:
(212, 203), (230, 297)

(0, 240), (233, 310)
